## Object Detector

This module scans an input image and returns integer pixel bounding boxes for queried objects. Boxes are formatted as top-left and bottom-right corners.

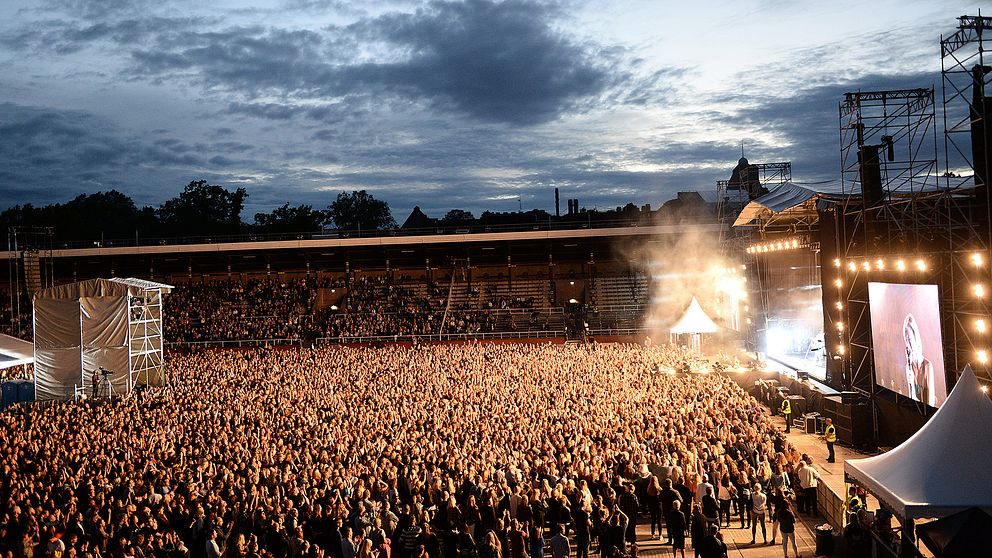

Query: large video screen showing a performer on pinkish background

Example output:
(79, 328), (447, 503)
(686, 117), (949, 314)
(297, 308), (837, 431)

(868, 283), (947, 407)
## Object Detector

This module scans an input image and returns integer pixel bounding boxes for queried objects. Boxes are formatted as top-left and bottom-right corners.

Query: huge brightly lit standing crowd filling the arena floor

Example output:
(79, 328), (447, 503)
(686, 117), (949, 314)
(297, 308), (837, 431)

(0, 343), (805, 558)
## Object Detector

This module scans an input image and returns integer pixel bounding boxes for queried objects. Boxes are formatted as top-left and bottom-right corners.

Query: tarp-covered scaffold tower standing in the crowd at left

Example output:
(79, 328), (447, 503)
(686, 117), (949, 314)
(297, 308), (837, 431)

(34, 279), (172, 401)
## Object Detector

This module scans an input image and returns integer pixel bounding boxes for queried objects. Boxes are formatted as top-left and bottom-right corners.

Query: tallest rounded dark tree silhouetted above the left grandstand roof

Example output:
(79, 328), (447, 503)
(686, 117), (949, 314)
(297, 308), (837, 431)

(158, 180), (248, 236)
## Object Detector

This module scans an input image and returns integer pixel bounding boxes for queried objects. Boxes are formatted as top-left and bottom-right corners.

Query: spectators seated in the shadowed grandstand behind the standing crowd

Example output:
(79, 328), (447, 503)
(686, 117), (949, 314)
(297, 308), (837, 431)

(165, 276), (547, 343)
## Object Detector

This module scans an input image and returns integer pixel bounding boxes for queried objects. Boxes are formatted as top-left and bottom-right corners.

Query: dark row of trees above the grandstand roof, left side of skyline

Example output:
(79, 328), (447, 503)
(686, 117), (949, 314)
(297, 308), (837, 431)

(0, 180), (396, 242)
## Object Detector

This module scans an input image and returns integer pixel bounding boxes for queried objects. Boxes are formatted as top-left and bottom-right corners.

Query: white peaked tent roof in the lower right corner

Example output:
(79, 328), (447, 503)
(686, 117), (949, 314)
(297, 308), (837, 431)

(844, 366), (992, 519)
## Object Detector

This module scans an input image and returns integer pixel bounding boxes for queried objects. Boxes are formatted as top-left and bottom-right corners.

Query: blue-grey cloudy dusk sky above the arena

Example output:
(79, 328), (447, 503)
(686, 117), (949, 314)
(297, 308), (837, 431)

(0, 0), (977, 222)
